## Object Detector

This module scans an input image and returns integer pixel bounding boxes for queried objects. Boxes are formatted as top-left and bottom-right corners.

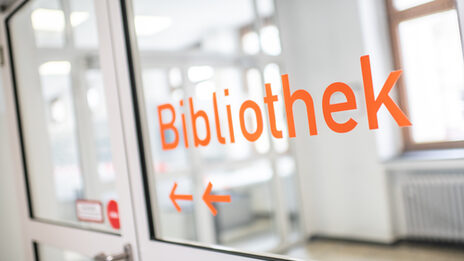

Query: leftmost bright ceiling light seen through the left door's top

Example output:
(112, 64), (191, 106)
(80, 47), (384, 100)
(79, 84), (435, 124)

(31, 8), (64, 32)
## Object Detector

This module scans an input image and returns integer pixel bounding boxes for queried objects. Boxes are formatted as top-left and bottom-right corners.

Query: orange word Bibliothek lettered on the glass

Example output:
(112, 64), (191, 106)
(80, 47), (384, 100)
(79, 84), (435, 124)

(158, 55), (411, 150)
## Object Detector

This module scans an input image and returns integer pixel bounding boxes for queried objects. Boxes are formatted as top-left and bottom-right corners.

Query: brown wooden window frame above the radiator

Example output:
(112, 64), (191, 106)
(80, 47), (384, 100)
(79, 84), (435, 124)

(385, 0), (464, 151)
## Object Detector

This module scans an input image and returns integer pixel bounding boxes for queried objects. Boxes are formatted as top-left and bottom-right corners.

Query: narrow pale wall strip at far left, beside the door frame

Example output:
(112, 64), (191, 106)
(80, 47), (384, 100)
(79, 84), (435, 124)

(0, 70), (24, 261)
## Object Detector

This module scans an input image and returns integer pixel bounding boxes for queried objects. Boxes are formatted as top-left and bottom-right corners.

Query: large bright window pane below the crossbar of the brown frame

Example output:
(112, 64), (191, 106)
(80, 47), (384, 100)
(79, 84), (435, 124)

(399, 10), (464, 143)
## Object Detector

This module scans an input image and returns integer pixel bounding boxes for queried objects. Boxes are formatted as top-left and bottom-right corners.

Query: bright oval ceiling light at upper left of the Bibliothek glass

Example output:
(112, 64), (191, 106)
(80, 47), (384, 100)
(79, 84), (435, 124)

(134, 15), (172, 36)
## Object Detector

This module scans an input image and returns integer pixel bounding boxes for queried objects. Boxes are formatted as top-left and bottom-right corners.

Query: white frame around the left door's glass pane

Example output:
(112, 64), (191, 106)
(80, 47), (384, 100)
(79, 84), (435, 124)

(0, 0), (139, 261)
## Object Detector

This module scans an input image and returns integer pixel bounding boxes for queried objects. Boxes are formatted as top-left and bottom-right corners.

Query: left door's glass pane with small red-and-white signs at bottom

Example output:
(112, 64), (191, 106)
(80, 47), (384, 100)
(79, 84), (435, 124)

(8, 0), (119, 233)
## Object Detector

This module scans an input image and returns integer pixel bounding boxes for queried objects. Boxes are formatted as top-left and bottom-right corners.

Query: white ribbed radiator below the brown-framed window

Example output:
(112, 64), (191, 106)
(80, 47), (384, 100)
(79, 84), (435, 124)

(396, 170), (464, 242)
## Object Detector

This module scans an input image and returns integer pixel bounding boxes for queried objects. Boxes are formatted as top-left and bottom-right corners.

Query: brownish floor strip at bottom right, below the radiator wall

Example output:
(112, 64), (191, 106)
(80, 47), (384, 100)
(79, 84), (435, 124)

(287, 240), (464, 261)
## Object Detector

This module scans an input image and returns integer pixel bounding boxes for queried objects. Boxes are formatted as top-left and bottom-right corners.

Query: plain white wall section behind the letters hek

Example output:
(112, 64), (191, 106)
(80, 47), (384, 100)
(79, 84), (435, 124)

(277, 0), (398, 242)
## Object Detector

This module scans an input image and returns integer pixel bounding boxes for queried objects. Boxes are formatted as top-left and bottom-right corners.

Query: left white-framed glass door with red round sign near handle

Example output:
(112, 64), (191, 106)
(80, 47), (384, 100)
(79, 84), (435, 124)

(5, 0), (138, 261)
